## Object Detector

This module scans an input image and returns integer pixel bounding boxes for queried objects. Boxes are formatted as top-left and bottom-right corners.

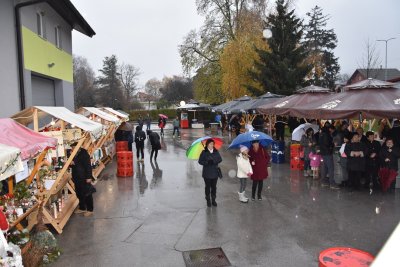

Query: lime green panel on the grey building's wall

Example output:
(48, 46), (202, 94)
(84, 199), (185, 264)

(22, 27), (73, 83)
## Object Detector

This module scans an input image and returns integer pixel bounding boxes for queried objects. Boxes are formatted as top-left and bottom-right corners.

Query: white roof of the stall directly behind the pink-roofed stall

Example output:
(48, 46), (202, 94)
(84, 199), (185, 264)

(12, 106), (103, 139)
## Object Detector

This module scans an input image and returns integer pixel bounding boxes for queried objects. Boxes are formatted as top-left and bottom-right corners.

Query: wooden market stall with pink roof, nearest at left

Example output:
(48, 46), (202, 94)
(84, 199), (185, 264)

(0, 118), (57, 230)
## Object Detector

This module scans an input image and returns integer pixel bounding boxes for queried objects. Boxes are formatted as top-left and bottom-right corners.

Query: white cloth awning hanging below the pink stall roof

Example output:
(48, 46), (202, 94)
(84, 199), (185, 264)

(0, 143), (24, 181)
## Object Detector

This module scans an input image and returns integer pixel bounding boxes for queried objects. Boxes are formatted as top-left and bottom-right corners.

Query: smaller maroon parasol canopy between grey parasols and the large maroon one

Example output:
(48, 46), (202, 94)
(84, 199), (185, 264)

(257, 85), (330, 116)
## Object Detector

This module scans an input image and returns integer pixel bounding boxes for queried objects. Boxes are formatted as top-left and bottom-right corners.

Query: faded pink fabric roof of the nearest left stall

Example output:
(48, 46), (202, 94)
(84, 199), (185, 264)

(0, 118), (57, 160)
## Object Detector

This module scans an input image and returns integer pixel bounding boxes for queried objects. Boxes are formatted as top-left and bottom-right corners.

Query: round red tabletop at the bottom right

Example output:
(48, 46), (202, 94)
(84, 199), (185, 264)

(318, 247), (375, 267)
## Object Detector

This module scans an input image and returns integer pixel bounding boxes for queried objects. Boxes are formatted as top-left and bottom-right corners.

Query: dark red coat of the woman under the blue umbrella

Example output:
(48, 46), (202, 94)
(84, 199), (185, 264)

(249, 146), (270, 181)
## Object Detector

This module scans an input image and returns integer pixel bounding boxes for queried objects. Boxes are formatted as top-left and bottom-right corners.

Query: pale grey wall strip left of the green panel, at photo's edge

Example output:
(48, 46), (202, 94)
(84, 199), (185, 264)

(0, 0), (20, 118)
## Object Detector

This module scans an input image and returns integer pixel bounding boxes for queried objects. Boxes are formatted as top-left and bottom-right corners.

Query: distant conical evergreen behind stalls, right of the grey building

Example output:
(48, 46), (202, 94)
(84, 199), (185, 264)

(96, 55), (125, 109)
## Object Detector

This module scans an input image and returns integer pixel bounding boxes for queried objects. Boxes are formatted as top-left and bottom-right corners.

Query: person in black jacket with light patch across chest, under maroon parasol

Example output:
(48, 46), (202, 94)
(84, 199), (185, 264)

(344, 132), (366, 190)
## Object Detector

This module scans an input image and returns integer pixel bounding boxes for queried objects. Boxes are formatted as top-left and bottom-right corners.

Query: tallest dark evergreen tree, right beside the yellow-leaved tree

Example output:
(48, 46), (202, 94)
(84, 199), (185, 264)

(248, 0), (310, 95)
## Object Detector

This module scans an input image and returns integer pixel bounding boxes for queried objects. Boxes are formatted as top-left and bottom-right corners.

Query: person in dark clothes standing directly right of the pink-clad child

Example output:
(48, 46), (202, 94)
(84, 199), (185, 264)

(318, 124), (340, 190)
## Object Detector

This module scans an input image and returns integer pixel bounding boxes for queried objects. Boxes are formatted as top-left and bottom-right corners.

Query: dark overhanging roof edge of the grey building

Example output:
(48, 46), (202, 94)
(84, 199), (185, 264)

(46, 0), (96, 37)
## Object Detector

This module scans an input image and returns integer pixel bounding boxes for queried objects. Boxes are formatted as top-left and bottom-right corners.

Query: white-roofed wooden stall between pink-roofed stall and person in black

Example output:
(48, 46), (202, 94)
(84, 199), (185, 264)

(12, 106), (106, 233)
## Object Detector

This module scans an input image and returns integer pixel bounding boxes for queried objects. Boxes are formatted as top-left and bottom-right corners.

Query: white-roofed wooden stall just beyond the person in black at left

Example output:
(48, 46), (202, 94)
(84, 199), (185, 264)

(76, 107), (122, 178)
